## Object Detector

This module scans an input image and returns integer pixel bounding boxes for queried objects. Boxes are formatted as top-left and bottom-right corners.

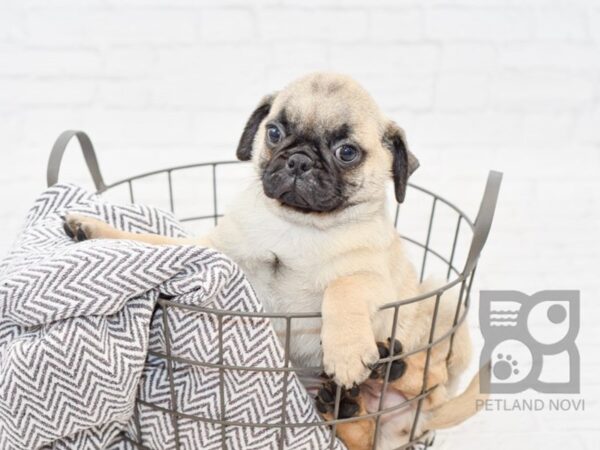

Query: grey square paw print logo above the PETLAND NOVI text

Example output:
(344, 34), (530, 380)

(479, 291), (579, 394)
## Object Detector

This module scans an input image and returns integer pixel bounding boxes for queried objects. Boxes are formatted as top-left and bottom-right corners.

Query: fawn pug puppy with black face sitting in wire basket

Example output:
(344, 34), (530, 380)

(65, 73), (486, 449)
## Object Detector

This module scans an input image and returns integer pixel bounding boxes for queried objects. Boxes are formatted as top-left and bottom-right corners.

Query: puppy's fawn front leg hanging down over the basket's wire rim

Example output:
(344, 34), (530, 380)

(321, 273), (383, 388)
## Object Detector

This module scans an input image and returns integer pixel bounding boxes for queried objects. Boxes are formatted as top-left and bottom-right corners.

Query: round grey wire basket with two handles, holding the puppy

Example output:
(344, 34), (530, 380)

(47, 131), (502, 450)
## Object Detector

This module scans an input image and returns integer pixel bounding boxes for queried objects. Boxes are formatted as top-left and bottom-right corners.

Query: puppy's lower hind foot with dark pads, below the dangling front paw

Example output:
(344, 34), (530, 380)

(316, 381), (375, 450)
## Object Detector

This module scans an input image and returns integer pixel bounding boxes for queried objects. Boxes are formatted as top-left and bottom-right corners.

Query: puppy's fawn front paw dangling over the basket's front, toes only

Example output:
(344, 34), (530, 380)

(322, 332), (379, 388)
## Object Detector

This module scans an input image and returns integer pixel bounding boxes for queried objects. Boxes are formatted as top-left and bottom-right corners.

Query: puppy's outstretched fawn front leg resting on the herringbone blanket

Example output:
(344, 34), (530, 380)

(63, 213), (208, 246)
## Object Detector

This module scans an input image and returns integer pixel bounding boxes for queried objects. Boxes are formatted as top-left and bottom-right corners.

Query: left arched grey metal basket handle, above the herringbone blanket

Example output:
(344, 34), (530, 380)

(46, 130), (106, 191)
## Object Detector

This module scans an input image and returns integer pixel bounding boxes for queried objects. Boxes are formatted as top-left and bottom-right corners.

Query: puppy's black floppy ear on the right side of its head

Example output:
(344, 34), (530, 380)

(383, 122), (419, 203)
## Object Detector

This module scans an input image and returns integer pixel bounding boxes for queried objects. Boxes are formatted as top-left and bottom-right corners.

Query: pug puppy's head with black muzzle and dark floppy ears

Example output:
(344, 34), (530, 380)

(237, 73), (418, 219)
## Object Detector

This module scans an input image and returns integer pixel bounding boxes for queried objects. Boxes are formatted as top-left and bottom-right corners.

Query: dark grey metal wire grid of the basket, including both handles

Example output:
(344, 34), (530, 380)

(47, 131), (502, 450)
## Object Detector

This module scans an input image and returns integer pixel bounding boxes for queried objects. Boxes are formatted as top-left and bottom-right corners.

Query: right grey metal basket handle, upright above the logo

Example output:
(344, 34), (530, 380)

(462, 170), (502, 276)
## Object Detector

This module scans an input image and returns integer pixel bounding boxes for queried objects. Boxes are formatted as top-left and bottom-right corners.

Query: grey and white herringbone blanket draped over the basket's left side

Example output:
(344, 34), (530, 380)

(0, 185), (343, 450)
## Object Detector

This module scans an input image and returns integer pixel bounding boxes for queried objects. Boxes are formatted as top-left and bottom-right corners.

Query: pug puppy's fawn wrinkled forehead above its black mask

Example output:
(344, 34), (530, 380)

(269, 79), (380, 139)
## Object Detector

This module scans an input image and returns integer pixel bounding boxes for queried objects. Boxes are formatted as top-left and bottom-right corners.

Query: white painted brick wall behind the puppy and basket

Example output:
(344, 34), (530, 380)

(0, 0), (600, 450)
